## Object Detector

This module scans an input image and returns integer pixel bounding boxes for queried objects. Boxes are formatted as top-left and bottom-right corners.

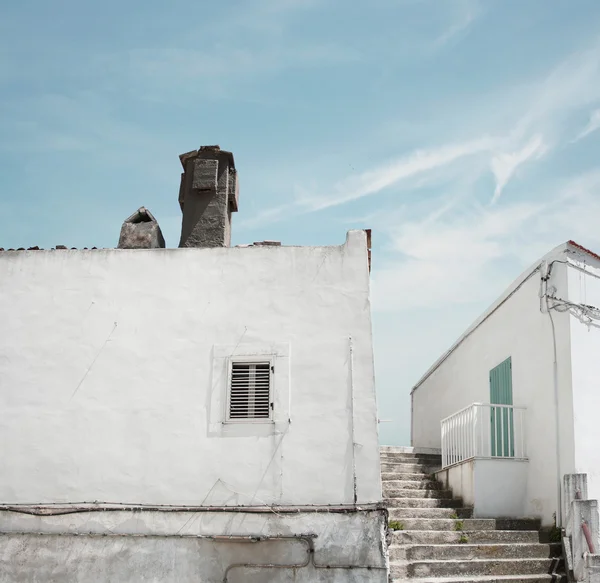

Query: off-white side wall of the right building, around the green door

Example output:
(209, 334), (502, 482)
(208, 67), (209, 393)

(412, 250), (574, 525)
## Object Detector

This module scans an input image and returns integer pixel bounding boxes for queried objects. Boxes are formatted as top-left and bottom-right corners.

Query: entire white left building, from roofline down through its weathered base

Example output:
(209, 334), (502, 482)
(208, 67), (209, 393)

(0, 145), (386, 583)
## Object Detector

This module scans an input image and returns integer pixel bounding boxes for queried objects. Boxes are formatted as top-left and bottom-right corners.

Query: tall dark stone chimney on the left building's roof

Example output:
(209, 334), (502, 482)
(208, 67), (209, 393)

(179, 146), (239, 247)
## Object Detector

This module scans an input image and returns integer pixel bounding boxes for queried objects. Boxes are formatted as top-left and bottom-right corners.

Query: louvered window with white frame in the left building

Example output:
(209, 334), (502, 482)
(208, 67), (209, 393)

(228, 361), (272, 421)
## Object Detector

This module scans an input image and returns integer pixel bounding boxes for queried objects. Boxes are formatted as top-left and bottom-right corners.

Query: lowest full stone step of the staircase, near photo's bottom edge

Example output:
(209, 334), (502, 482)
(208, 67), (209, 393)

(390, 559), (554, 578)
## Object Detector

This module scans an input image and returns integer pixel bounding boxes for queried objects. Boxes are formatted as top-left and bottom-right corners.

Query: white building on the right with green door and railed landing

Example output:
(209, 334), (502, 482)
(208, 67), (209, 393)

(412, 241), (600, 525)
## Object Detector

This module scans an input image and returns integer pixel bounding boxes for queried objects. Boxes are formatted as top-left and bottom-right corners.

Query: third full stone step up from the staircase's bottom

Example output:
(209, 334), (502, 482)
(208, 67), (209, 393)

(391, 530), (540, 545)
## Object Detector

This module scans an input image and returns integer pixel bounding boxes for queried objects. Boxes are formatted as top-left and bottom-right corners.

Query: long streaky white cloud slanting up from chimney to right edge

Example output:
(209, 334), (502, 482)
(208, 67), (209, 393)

(241, 36), (600, 226)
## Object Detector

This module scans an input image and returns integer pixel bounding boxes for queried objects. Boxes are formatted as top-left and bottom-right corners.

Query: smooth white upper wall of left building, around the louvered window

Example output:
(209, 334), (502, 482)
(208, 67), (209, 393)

(0, 231), (381, 505)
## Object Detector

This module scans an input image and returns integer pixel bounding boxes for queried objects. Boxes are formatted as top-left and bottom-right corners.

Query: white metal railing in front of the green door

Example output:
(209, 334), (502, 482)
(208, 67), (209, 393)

(442, 403), (527, 468)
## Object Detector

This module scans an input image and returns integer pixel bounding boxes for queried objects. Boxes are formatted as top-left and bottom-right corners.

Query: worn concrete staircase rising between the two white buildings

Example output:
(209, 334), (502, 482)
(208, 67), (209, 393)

(381, 446), (563, 583)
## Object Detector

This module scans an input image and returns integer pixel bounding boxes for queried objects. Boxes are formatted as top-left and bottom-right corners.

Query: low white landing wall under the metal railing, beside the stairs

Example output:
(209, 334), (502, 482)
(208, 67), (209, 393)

(436, 459), (529, 518)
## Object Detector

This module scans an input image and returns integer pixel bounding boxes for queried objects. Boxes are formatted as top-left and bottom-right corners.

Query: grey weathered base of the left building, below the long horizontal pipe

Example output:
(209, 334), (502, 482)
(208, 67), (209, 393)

(0, 511), (387, 583)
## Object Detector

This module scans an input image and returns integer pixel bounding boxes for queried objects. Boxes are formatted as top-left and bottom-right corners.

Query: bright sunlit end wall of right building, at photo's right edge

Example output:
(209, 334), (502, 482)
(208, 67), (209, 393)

(568, 254), (600, 508)
